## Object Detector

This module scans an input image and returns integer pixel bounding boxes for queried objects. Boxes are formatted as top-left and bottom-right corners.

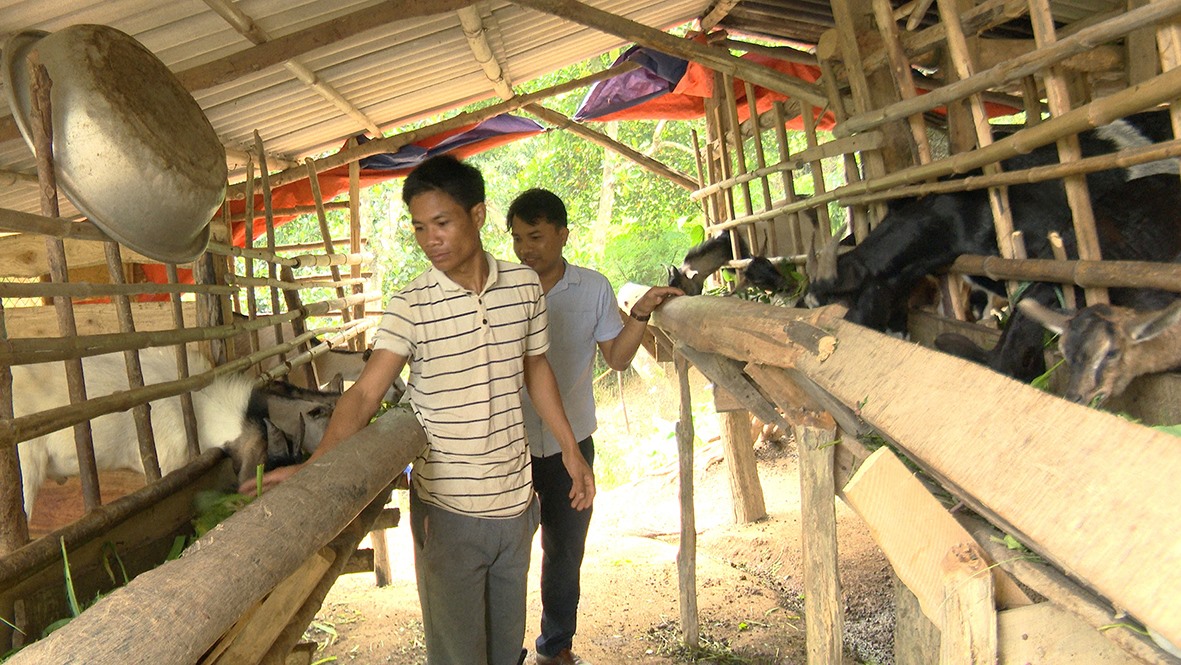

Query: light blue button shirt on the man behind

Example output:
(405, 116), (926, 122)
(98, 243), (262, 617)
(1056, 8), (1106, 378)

(521, 263), (624, 457)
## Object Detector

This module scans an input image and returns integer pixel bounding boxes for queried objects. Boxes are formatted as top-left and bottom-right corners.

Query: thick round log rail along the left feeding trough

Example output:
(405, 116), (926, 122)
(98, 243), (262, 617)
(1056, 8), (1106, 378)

(8, 410), (425, 665)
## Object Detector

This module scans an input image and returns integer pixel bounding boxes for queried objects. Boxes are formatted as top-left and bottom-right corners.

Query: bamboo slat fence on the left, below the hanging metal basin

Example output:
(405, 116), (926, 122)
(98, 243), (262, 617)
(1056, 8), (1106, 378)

(0, 125), (380, 566)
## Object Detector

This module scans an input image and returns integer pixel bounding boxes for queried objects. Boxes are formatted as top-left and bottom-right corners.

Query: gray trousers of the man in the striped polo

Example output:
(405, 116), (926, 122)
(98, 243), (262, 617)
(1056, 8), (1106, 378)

(410, 484), (541, 665)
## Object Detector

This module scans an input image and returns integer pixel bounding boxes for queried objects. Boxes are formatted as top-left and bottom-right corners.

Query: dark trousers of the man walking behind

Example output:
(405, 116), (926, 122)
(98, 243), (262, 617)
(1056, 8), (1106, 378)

(533, 437), (594, 656)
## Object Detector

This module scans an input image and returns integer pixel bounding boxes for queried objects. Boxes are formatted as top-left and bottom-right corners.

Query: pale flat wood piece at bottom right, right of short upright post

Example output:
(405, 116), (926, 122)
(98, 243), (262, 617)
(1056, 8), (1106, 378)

(997, 602), (1141, 665)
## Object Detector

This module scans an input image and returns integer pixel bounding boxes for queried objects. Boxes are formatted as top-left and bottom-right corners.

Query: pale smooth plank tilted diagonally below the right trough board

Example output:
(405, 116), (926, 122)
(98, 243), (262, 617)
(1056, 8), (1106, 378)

(844, 446), (1030, 625)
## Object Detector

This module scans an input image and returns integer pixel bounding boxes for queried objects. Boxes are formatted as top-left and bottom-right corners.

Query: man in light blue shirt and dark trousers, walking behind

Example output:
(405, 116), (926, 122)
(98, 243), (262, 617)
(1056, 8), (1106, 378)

(508, 189), (683, 665)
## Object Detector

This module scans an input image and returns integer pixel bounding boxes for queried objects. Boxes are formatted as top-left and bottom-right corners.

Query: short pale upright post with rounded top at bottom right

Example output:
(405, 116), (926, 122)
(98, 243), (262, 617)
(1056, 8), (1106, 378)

(939, 543), (997, 665)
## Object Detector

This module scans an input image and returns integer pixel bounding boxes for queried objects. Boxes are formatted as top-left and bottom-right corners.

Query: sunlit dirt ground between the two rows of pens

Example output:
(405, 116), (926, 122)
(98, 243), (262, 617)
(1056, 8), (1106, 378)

(306, 409), (894, 665)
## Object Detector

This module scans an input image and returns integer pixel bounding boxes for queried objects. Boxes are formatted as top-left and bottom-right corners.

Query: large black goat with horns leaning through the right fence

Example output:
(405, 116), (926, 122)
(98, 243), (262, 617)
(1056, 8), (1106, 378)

(807, 112), (1181, 380)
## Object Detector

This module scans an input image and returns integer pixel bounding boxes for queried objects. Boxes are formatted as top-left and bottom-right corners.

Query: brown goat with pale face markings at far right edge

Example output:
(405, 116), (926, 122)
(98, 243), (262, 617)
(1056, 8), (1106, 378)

(1018, 300), (1181, 404)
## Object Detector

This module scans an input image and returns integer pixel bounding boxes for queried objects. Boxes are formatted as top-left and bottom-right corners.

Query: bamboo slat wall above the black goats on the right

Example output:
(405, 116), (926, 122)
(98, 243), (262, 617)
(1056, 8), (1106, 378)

(691, 0), (1181, 301)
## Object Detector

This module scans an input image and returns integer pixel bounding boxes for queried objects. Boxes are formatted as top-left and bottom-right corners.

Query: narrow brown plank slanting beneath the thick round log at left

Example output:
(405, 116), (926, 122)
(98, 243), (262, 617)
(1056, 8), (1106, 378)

(202, 547), (337, 665)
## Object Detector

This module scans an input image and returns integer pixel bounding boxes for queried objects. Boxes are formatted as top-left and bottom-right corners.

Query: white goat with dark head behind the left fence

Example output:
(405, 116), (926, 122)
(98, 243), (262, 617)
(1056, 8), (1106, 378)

(12, 348), (334, 514)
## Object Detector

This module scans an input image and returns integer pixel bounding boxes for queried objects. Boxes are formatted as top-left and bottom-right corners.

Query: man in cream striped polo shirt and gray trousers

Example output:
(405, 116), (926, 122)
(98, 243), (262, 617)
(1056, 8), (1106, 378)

(272, 155), (595, 665)
